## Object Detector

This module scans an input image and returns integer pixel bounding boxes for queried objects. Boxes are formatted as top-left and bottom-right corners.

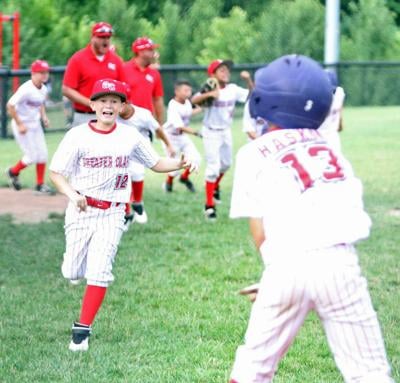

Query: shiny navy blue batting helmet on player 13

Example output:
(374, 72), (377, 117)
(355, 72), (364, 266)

(250, 55), (332, 129)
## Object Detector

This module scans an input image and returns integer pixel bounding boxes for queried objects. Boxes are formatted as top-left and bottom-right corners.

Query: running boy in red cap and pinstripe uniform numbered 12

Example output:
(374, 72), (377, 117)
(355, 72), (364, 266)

(50, 79), (196, 351)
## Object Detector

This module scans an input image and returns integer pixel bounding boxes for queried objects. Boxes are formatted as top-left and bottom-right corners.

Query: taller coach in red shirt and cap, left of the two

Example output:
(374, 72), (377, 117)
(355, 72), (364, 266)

(62, 22), (124, 126)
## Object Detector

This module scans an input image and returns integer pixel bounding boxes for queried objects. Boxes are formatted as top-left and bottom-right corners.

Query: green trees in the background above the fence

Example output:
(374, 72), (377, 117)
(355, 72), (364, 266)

(1, 0), (400, 67)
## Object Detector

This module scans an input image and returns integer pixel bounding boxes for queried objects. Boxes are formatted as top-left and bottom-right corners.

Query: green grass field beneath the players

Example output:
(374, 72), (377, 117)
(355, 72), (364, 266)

(0, 107), (400, 383)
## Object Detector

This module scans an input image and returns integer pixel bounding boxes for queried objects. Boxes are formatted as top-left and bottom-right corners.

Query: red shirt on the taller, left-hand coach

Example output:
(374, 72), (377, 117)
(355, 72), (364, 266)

(63, 44), (125, 112)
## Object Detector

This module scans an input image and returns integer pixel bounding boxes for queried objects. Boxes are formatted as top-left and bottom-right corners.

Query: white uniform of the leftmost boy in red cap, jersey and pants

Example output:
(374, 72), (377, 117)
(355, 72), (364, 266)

(8, 80), (48, 165)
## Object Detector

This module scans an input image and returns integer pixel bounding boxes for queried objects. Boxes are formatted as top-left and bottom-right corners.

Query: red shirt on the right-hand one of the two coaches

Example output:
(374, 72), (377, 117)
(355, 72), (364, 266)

(124, 58), (164, 113)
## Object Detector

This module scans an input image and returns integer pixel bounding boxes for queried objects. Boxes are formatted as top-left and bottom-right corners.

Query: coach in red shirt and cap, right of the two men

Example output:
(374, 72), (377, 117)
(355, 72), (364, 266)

(124, 37), (164, 125)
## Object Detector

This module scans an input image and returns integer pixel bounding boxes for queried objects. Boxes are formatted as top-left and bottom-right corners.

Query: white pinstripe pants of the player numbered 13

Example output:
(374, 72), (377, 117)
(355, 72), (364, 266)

(232, 245), (393, 383)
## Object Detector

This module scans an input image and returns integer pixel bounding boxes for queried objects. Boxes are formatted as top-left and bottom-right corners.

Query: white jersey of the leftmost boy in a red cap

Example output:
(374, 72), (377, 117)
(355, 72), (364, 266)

(8, 80), (47, 124)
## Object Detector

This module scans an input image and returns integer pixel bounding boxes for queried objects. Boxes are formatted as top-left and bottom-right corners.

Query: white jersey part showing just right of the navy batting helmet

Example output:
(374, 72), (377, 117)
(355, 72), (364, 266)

(318, 86), (346, 150)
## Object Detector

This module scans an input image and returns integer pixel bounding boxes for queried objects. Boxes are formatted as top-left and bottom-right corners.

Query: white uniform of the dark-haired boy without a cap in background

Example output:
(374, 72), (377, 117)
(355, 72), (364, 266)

(163, 99), (201, 177)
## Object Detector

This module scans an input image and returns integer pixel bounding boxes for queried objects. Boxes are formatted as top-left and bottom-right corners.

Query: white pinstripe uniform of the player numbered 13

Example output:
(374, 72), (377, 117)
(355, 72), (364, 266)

(230, 129), (392, 383)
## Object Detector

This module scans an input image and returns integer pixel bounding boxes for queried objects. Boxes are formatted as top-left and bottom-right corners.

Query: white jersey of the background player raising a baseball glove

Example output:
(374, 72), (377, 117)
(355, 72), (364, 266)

(203, 84), (249, 130)
